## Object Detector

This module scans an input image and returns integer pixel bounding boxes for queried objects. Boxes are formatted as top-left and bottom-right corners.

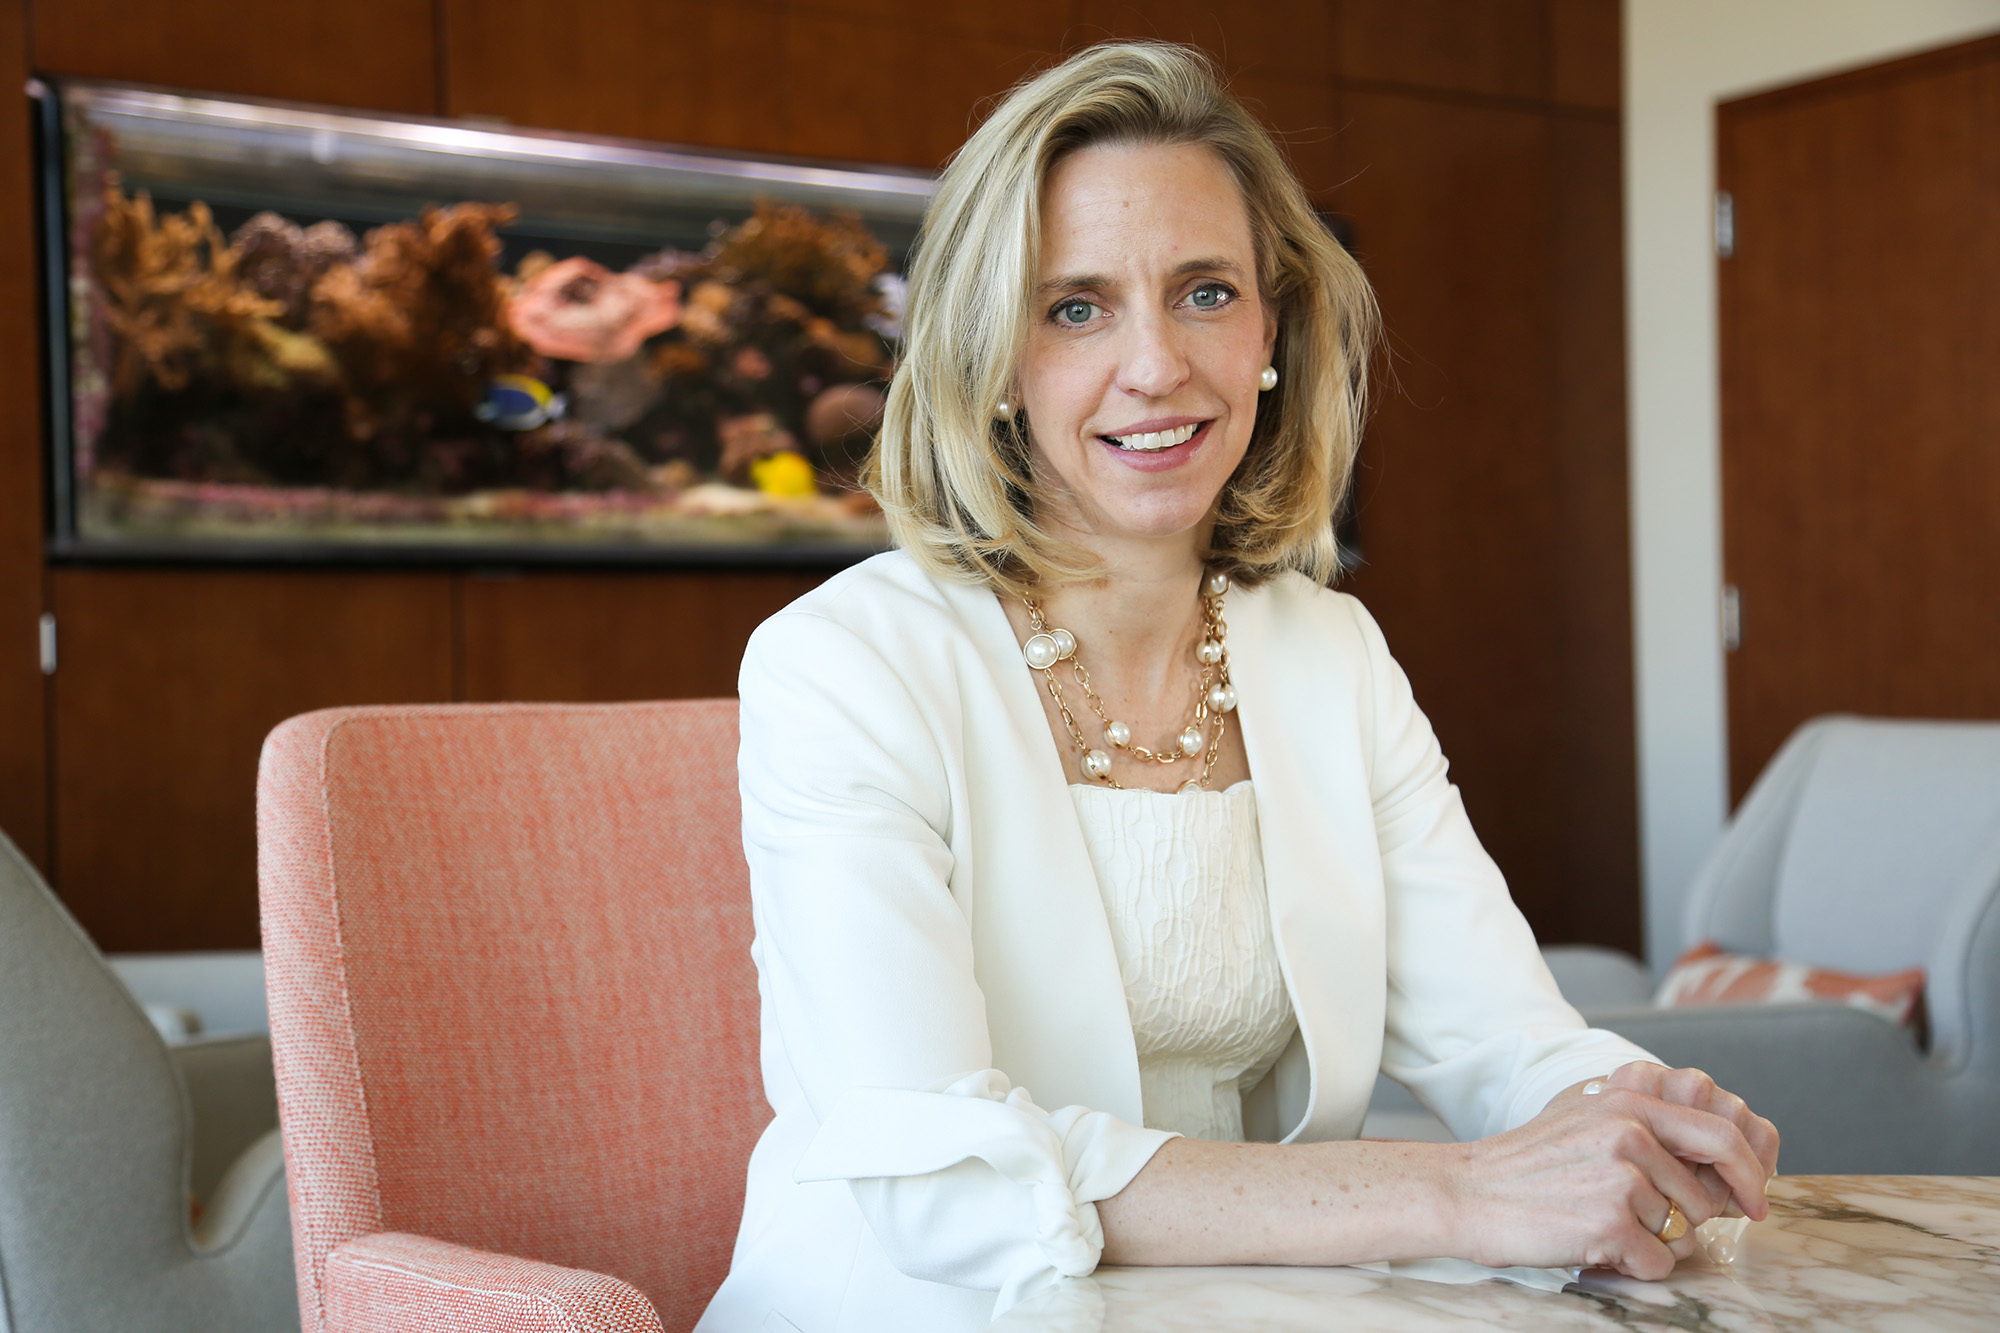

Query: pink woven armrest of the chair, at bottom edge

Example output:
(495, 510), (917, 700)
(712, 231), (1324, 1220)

(326, 1231), (662, 1333)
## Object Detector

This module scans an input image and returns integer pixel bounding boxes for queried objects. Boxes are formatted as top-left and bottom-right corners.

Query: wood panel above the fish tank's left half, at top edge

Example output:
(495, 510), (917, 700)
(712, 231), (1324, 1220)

(24, 0), (438, 114)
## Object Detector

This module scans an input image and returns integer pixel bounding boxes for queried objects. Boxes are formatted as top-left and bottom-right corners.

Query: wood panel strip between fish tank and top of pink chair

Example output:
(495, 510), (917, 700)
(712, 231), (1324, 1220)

(460, 572), (820, 703)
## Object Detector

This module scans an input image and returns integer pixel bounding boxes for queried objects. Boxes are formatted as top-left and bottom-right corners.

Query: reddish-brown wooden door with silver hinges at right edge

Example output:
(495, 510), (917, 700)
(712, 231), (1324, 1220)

(1718, 38), (2000, 799)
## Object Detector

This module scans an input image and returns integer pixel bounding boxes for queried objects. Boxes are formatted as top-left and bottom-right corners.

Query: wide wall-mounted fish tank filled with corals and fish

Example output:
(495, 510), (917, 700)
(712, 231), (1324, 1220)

(34, 80), (934, 564)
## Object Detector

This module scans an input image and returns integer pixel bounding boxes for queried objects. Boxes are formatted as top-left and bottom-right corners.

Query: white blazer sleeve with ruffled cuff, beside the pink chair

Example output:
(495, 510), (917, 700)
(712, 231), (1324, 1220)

(740, 610), (1174, 1307)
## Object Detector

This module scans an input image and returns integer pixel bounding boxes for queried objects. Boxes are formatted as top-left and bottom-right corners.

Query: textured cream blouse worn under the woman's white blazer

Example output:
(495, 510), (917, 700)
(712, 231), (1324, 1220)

(1070, 783), (1298, 1143)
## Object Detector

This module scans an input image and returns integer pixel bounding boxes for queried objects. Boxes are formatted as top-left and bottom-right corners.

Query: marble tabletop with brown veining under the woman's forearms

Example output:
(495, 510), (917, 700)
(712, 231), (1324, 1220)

(990, 1175), (2000, 1333)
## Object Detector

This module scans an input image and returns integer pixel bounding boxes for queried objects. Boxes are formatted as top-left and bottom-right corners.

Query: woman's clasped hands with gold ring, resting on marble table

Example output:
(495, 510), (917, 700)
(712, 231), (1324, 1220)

(1448, 1063), (1778, 1281)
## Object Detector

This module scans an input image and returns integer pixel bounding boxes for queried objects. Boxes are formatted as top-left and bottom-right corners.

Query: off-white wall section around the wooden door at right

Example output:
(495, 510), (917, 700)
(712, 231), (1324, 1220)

(1624, 0), (2000, 967)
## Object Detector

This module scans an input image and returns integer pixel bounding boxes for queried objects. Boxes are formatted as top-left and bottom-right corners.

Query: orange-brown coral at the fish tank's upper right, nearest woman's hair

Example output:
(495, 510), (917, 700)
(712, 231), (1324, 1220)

(710, 200), (888, 328)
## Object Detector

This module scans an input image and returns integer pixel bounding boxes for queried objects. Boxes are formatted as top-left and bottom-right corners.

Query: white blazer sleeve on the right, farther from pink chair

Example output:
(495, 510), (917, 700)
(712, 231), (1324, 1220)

(1346, 598), (1654, 1139)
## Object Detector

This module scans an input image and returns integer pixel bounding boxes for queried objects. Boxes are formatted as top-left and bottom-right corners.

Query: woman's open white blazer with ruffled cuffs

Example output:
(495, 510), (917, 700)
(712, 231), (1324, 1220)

(698, 552), (1650, 1333)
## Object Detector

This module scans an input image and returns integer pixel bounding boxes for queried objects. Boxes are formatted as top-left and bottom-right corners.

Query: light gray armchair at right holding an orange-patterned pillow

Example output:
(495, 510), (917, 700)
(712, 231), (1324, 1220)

(1366, 717), (2000, 1175)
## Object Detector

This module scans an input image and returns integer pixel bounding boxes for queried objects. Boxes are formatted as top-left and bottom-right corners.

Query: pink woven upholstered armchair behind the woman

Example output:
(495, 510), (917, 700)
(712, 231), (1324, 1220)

(258, 701), (770, 1333)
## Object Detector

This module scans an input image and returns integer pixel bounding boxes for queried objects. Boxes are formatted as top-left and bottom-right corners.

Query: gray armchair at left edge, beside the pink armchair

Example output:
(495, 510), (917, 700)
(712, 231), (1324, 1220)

(0, 837), (298, 1333)
